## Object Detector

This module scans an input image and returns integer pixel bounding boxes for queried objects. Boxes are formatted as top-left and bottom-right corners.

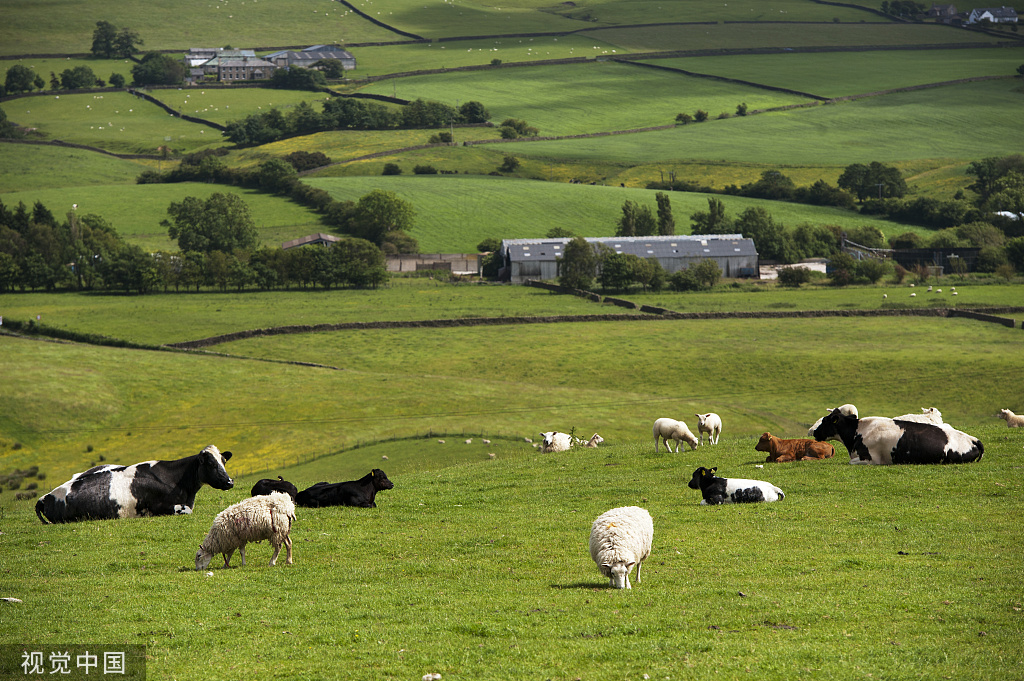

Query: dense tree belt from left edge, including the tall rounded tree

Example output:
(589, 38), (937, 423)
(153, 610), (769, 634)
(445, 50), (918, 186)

(0, 194), (388, 293)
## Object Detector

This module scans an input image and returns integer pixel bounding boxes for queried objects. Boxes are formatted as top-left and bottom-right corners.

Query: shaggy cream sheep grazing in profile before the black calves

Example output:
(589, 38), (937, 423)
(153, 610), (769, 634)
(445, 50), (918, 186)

(196, 492), (295, 569)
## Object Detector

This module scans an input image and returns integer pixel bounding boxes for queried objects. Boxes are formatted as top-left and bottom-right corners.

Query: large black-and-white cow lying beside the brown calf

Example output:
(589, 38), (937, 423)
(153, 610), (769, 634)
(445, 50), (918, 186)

(811, 405), (985, 466)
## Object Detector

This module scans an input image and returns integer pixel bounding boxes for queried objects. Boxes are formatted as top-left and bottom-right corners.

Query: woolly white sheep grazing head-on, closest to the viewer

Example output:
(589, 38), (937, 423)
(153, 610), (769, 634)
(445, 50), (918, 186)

(590, 506), (654, 589)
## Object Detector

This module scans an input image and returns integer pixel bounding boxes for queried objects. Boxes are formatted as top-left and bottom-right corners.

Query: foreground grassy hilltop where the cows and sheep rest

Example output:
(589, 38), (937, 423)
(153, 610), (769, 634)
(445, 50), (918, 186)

(0, 428), (1024, 681)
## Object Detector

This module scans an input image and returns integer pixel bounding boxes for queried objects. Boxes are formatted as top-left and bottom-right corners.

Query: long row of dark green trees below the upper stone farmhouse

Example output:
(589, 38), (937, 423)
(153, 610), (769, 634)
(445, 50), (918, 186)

(223, 96), (489, 146)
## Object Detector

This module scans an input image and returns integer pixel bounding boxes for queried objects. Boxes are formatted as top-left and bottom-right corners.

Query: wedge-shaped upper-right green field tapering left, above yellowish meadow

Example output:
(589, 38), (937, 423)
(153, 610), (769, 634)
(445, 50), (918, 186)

(502, 78), (1024, 165)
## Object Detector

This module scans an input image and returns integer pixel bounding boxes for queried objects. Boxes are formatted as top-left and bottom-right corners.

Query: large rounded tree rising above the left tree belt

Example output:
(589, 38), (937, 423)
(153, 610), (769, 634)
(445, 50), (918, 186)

(160, 193), (259, 253)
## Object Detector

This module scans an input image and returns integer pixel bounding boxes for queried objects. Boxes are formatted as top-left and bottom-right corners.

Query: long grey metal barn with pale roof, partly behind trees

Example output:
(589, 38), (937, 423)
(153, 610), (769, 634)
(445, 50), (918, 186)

(501, 235), (758, 284)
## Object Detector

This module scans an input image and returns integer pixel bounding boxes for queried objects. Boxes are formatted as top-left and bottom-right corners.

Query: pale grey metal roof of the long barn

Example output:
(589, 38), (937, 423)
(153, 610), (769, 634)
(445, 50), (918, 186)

(502, 235), (758, 261)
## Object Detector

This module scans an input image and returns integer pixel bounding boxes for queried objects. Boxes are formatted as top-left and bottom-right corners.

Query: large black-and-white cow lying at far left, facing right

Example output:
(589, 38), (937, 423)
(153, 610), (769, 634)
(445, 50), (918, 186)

(36, 444), (234, 523)
